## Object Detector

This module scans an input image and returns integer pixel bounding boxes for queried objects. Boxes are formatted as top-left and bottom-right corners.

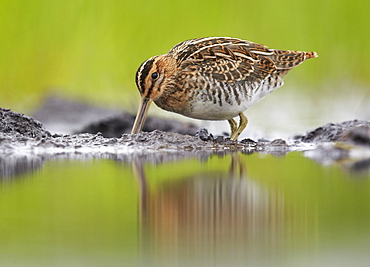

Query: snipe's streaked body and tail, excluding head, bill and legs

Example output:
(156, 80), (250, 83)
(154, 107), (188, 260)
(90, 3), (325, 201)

(156, 37), (317, 120)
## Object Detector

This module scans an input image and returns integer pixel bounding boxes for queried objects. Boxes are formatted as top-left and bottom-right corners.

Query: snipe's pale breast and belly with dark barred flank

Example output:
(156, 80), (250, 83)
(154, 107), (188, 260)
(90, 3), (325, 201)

(155, 75), (282, 120)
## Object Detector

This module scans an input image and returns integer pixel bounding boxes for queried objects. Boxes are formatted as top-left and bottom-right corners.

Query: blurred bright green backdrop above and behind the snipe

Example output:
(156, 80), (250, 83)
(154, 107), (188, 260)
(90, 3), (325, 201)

(0, 0), (370, 112)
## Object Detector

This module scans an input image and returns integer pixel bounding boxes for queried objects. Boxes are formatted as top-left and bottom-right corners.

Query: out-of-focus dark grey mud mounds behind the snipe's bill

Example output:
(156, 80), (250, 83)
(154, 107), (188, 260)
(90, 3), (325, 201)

(32, 96), (198, 137)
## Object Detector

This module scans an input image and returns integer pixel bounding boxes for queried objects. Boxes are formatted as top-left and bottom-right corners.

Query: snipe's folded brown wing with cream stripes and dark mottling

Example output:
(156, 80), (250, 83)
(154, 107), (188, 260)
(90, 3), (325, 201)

(176, 37), (276, 83)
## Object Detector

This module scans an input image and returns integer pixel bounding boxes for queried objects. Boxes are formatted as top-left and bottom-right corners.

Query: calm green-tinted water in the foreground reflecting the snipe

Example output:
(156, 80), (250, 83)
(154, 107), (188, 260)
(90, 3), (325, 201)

(0, 152), (370, 266)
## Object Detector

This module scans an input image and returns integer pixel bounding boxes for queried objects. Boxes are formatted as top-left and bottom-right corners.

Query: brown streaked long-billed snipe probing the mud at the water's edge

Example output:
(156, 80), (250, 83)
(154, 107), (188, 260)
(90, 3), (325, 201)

(132, 37), (317, 140)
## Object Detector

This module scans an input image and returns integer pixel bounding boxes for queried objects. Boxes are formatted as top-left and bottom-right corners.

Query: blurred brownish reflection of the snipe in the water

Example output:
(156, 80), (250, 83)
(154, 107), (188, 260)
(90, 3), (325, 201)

(133, 154), (294, 255)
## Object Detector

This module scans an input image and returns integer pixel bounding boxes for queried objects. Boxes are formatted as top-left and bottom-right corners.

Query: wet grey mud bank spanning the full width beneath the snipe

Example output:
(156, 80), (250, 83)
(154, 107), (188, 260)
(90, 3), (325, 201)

(0, 108), (370, 151)
